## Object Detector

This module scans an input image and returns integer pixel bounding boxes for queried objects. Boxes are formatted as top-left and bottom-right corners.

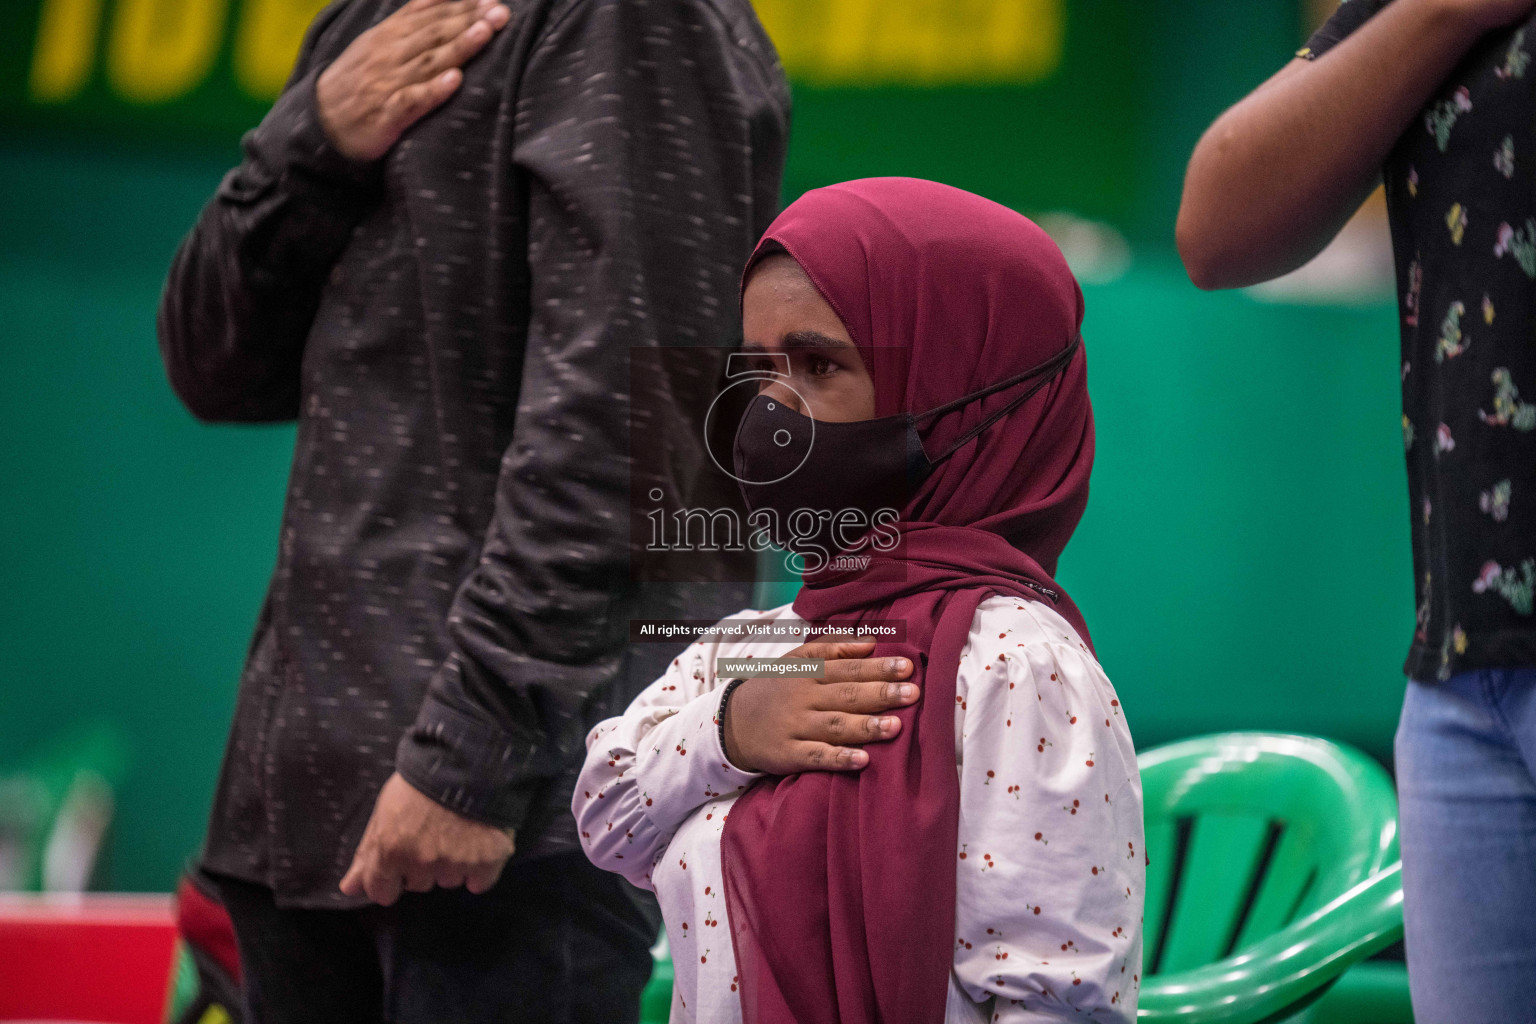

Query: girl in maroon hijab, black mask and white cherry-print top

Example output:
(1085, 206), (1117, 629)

(573, 178), (1144, 1024)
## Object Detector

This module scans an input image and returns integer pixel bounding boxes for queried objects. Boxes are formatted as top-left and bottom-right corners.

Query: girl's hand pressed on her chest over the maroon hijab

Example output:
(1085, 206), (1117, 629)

(723, 642), (919, 775)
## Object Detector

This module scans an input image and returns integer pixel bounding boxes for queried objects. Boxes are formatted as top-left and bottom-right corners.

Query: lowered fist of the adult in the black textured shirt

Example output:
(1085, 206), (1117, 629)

(341, 772), (516, 906)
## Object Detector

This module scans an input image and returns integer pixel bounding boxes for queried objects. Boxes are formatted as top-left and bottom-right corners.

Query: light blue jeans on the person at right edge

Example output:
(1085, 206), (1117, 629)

(1396, 669), (1536, 1024)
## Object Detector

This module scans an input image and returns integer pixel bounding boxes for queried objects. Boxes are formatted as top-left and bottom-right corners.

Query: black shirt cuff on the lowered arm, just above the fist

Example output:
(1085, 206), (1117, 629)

(395, 694), (548, 829)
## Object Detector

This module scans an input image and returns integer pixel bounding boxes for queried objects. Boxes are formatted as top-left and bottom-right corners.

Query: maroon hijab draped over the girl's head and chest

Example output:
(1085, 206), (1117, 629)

(722, 178), (1094, 1024)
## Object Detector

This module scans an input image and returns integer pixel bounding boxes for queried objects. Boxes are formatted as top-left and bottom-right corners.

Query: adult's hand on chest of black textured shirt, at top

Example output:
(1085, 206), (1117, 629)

(315, 0), (511, 161)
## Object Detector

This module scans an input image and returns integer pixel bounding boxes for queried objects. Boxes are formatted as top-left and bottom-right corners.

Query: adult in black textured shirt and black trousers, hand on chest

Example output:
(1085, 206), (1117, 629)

(160, 0), (790, 1024)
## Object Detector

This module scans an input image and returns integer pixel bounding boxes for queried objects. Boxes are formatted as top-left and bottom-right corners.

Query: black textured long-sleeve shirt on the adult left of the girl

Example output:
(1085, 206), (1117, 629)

(160, 0), (788, 906)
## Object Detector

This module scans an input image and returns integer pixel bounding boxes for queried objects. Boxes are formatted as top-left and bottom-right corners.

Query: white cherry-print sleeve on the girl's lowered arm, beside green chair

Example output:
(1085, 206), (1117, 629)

(954, 597), (1146, 1024)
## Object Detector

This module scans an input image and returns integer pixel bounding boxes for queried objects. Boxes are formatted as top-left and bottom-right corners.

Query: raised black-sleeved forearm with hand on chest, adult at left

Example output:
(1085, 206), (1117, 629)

(158, 0), (507, 422)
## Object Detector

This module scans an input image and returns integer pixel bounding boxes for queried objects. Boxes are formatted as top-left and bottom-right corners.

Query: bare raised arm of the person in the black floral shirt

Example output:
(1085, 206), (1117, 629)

(1178, 0), (1531, 289)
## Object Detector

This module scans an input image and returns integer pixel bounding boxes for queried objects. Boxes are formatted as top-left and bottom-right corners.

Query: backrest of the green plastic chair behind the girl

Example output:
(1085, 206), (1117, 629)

(1140, 732), (1398, 975)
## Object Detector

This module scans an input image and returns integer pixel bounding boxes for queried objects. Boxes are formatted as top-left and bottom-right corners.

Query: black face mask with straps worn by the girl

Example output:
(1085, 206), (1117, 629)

(734, 335), (1083, 551)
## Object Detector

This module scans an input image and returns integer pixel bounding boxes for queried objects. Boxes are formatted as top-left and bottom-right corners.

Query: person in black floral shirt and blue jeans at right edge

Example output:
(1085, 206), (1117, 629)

(1178, 0), (1536, 1024)
